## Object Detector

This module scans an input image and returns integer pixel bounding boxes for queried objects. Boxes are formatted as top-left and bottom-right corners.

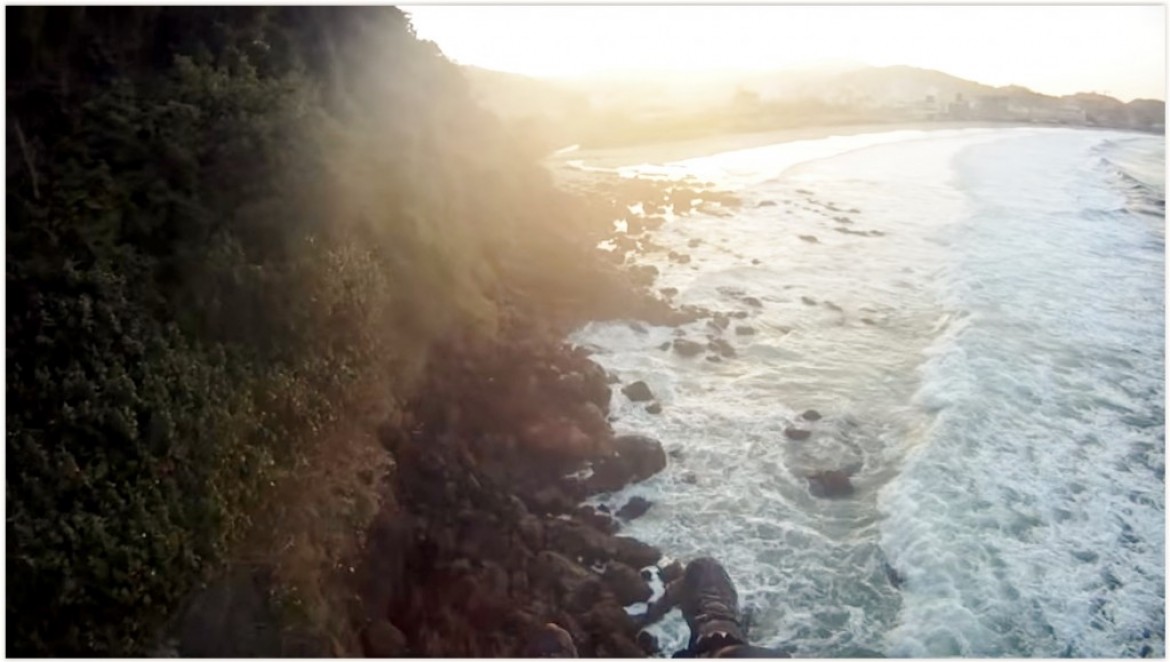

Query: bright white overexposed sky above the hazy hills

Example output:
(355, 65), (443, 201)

(401, 5), (1166, 101)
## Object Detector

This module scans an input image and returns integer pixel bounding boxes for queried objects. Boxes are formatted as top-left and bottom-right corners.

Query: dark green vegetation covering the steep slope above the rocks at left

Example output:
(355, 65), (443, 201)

(6, 7), (622, 656)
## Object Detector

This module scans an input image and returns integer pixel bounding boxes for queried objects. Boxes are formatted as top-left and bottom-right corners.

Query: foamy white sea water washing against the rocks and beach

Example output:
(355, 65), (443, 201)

(570, 127), (1165, 657)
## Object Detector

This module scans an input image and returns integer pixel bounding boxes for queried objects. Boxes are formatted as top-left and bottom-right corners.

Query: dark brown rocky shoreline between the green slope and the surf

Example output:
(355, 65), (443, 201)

(355, 173), (738, 657)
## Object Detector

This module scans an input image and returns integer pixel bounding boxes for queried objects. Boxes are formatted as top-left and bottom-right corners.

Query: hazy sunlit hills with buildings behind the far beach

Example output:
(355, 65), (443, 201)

(464, 61), (1165, 146)
